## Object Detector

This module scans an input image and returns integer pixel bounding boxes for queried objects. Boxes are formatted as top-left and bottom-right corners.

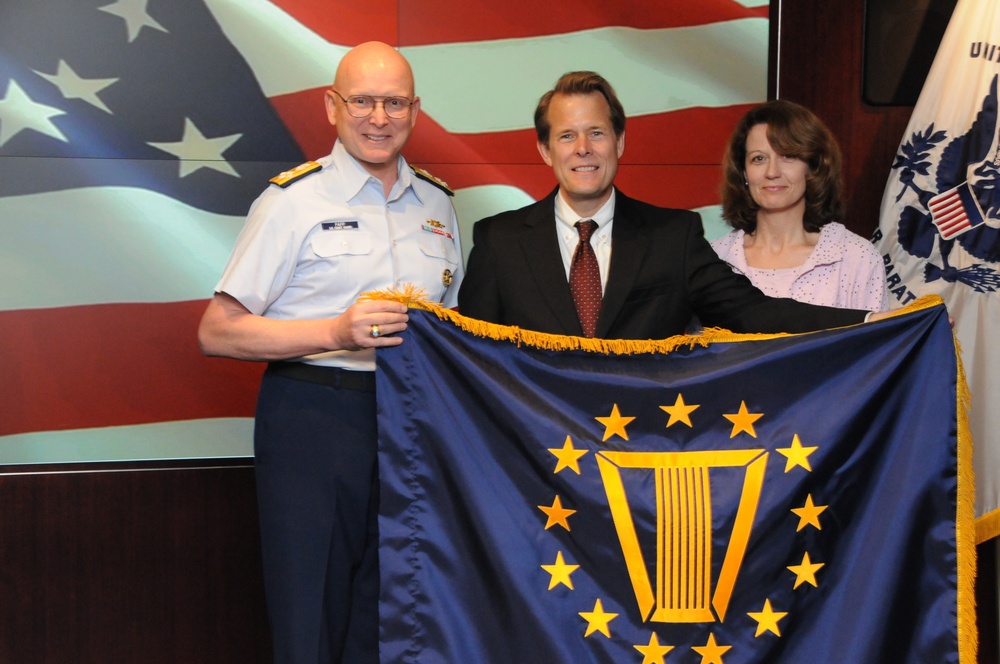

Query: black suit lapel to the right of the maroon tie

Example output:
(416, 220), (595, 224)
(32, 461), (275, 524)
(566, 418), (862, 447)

(596, 191), (650, 337)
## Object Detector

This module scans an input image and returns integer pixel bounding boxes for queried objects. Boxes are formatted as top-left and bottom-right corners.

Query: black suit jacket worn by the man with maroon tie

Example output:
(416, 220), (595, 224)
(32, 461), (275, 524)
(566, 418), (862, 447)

(458, 190), (867, 339)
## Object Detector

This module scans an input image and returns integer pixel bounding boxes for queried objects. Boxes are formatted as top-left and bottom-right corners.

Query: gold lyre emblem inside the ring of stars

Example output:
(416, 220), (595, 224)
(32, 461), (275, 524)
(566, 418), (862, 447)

(597, 449), (768, 623)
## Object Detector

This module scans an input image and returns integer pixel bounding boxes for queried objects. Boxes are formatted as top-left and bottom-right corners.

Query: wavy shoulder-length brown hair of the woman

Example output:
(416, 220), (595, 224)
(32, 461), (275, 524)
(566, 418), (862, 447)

(721, 99), (844, 233)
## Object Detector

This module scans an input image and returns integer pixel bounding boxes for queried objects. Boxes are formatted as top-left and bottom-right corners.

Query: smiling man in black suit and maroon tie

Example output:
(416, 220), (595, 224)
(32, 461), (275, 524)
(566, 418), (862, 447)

(458, 72), (880, 339)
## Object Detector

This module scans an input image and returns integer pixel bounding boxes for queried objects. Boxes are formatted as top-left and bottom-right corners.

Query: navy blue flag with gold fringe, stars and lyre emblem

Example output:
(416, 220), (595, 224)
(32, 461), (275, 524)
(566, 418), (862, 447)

(377, 298), (976, 664)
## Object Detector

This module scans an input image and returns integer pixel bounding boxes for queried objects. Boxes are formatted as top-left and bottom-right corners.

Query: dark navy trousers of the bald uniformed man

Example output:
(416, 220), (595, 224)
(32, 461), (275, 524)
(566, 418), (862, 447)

(254, 364), (379, 664)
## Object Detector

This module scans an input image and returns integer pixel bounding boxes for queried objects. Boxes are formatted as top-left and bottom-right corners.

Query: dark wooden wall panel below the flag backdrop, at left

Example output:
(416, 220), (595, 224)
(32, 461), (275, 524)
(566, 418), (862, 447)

(0, 460), (271, 664)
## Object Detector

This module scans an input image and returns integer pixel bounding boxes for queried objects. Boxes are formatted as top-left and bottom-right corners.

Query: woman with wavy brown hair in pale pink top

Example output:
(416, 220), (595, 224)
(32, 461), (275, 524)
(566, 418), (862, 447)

(712, 100), (888, 311)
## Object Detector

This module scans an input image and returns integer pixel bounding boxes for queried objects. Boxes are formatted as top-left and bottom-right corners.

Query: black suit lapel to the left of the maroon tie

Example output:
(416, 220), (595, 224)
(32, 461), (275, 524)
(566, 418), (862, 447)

(521, 190), (583, 336)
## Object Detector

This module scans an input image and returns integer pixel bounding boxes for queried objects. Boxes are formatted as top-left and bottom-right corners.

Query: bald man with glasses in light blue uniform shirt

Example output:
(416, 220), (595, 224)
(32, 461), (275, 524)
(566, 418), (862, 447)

(198, 42), (462, 664)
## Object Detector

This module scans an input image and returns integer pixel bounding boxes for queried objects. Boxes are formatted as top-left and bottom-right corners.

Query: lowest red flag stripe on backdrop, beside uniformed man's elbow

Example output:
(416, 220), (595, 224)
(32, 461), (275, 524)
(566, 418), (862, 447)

(0, 301), (264, 435)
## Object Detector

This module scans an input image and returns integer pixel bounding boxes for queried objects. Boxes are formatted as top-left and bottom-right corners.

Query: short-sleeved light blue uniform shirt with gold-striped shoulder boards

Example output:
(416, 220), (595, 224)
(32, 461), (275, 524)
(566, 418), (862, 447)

(215, 140), (463, 371)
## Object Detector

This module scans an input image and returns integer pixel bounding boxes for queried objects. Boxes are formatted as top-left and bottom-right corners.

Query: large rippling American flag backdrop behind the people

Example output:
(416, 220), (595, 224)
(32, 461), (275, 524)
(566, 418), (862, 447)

(0, 0), (768, 464)
